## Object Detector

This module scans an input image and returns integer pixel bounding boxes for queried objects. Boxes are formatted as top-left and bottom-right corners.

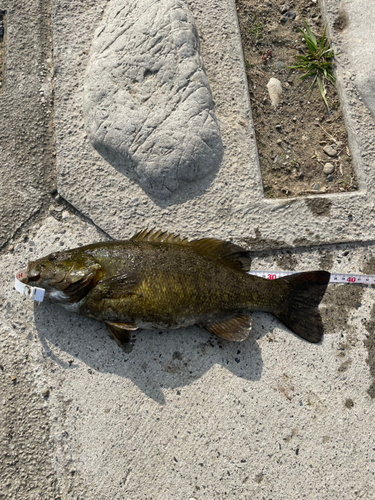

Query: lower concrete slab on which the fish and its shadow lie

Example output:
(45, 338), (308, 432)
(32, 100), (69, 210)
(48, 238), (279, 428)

(0, 211), (375, 500)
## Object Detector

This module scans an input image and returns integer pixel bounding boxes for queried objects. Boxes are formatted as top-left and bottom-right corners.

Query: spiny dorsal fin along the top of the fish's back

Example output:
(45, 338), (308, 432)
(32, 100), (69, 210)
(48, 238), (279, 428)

(131, 229), (251, 271)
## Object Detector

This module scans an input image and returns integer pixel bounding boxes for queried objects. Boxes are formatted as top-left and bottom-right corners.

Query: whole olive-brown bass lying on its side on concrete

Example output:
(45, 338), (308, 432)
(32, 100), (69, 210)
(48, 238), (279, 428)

(22, 229), (330, 348)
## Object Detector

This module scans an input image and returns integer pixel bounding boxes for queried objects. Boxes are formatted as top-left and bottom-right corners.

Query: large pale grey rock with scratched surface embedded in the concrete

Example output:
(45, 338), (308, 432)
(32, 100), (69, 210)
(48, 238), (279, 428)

(83, 0), (223, 199)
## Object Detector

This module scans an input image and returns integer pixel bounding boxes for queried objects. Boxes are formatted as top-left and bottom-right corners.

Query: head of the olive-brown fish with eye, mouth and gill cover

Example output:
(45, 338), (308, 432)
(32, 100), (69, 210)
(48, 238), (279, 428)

(21, 248), (102, 303)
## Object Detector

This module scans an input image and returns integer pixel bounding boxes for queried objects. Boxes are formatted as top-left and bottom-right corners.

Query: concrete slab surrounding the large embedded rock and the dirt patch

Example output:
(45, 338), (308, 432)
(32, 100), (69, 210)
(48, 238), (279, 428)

(53, 0), (375, 247)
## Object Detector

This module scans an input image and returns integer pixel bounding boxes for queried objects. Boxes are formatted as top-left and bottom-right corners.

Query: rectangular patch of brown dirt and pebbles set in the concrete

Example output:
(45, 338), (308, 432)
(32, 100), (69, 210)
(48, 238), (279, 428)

(236, 0), (358, 199)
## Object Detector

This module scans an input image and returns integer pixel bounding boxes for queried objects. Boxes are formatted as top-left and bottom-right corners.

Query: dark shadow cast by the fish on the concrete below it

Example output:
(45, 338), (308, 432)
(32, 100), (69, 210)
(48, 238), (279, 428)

(34, 303), (276, 404)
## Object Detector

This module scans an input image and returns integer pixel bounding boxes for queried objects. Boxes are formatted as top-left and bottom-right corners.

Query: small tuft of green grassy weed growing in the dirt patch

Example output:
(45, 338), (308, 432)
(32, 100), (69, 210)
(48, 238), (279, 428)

(289, 21), (336, 110)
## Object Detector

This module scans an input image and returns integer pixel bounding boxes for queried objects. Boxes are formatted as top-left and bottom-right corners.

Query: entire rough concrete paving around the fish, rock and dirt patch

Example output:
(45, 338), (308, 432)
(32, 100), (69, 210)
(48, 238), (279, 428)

(0, 0), (375, 500)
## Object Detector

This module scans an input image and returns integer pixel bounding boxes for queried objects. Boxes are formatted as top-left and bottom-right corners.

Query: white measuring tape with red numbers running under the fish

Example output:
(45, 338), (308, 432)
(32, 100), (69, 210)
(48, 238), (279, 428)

(14, 269), (375, 302)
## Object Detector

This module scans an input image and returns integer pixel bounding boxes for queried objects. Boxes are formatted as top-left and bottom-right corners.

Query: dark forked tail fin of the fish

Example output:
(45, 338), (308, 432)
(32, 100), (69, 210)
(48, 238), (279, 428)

(274, 271), (330, 343)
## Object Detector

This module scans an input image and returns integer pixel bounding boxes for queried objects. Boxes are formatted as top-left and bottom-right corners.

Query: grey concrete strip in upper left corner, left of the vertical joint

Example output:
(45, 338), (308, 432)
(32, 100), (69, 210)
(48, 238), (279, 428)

(0, 0), (56, 248)
